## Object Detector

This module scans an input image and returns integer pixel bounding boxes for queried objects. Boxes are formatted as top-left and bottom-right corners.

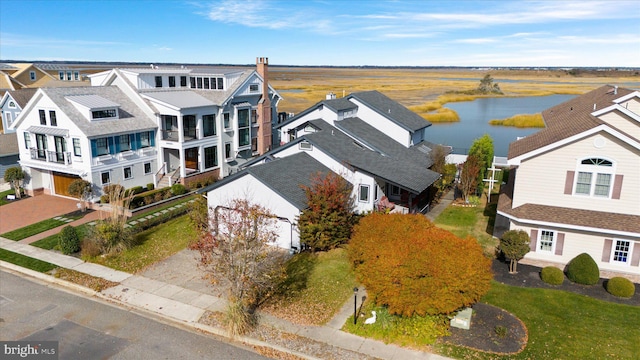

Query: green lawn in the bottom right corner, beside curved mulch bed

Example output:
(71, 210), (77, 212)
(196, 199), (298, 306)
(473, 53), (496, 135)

(438, 282), (640, 359)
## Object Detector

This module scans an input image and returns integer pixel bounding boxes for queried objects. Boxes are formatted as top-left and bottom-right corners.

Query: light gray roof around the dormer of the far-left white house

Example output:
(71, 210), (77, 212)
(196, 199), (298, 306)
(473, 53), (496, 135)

(41, 86), (157, 137)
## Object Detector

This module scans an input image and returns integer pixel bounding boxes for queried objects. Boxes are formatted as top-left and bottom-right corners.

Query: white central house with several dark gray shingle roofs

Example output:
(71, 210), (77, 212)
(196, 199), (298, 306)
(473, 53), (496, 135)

(203, 92), (440, 249)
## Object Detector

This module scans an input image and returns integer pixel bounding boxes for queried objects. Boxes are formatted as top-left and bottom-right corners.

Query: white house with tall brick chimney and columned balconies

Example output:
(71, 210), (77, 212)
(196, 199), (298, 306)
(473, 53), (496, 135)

(89, 58), (281, 187)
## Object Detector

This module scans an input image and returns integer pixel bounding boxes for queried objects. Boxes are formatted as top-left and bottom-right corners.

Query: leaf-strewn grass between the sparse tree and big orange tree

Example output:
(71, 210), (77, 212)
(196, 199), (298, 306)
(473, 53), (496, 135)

(261, 249), (356, 325)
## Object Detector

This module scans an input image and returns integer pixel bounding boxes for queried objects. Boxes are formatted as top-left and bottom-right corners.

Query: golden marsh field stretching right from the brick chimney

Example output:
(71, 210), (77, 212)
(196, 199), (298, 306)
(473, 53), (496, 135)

(269, 67), (640, 126)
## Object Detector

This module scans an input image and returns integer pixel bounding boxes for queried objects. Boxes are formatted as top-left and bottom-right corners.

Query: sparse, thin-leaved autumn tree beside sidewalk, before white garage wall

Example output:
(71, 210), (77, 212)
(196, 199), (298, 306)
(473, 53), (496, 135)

(191, 199), (289, 335)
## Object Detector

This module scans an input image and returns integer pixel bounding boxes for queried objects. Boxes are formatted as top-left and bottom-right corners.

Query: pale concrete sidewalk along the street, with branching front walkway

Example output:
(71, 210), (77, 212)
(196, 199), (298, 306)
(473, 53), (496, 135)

(0, 238), (447, 360)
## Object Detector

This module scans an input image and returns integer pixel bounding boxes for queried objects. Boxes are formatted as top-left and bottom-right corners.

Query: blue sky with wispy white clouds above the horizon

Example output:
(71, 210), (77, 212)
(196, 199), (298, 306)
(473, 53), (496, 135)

(0, 0), (640, 67)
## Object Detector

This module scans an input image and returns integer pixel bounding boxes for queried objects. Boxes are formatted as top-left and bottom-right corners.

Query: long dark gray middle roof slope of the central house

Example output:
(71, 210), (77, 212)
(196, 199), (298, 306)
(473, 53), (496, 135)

(303, 120), (440, 194)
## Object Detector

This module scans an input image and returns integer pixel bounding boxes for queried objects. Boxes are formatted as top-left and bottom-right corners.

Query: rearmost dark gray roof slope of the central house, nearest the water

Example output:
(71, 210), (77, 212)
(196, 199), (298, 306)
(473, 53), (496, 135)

(347, 90), (431, 132)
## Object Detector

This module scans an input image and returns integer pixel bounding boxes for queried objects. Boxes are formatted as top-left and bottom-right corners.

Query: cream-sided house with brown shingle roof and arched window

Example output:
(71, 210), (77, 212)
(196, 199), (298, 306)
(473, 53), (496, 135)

(495, 86), (640, 275)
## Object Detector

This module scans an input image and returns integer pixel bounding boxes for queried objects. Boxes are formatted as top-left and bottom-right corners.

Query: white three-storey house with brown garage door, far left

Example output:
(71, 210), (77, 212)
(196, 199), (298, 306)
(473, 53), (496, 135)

(14, 86), (157, 196)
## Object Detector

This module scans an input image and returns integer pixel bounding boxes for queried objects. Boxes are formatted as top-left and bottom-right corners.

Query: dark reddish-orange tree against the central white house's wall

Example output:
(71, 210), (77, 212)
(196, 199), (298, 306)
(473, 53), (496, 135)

(298, 172), (357, 251)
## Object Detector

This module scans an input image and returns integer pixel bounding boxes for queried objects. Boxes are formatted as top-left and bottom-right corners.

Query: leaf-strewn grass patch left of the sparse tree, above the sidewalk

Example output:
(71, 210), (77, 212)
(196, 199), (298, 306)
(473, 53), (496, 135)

(88, 215), (196, 273)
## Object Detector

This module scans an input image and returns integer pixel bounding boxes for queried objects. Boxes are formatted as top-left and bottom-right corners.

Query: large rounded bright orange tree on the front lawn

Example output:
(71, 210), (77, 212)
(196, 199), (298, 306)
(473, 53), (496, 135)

(348, 213), (492, 316)
